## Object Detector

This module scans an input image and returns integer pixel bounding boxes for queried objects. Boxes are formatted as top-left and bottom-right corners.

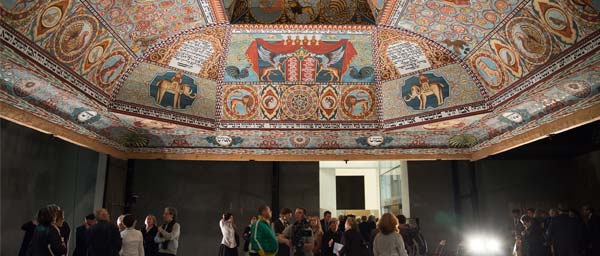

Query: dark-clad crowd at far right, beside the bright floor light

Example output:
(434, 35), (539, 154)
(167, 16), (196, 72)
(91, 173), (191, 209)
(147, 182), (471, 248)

(512, 205), (600, 256)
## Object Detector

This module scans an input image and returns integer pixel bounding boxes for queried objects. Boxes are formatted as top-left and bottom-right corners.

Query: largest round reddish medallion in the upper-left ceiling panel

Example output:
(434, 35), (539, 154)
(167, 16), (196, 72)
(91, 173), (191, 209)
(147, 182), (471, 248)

(54, 14), (98, 62)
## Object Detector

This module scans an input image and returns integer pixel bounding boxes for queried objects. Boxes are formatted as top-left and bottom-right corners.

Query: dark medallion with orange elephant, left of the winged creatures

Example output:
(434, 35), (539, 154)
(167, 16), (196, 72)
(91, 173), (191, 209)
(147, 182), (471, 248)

(150, 71), (198, 109)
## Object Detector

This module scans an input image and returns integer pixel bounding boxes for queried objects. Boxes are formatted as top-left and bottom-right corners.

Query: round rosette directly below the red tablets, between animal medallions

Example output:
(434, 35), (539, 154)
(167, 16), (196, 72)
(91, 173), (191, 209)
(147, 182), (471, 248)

(281, 85), (319, 120)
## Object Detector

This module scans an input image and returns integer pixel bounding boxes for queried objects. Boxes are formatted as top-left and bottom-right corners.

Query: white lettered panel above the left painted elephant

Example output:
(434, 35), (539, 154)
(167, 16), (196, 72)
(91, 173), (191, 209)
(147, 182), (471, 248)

(169, 40), (213, 74)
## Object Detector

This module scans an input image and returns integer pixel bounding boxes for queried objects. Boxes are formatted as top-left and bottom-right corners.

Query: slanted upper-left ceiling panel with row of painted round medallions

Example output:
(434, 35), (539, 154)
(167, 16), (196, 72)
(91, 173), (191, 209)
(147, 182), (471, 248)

(0, 0), (133, 95)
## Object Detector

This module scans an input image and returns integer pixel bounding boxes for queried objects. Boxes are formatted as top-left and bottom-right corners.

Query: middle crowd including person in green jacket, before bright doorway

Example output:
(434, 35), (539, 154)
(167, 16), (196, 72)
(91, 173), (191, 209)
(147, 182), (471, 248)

(219, 205), (408, 256)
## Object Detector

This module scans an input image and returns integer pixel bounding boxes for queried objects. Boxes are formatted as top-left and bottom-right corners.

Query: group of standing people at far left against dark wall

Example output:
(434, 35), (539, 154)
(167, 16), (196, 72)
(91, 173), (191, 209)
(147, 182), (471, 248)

(19, 204), (181, 256)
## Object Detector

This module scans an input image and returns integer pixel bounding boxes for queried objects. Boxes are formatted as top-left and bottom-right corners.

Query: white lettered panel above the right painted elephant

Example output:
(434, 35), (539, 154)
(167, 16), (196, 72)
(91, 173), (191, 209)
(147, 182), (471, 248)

(387, 41), (431, 75)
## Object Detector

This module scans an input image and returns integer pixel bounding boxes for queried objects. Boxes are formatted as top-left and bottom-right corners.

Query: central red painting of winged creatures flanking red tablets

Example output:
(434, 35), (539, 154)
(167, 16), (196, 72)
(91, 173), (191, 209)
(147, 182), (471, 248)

(246, 35), (364, 82)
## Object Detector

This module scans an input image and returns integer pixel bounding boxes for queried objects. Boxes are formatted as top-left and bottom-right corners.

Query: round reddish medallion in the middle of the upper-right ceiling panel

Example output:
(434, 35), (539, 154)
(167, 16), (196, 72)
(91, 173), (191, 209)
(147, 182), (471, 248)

(506, 17), (552, 64)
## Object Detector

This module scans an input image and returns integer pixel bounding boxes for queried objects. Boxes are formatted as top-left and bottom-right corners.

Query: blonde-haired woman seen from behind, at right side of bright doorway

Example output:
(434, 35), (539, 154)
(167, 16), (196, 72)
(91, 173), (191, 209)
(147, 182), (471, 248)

(373, 213), (408, 256)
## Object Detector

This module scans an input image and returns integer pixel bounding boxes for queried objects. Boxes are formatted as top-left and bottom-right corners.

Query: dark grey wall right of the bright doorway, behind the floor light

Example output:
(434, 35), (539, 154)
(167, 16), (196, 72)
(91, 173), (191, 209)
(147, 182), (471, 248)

(408, 151), (600, 248)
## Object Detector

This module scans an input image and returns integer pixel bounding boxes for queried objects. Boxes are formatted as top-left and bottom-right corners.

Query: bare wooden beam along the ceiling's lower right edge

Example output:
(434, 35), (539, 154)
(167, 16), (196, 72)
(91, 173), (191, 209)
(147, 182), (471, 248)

(471, 104), (600, 161)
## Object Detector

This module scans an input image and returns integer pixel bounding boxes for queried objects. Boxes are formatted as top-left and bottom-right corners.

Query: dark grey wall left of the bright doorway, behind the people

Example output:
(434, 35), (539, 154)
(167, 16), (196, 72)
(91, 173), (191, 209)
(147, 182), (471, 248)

(132, 160), (319, 255)
